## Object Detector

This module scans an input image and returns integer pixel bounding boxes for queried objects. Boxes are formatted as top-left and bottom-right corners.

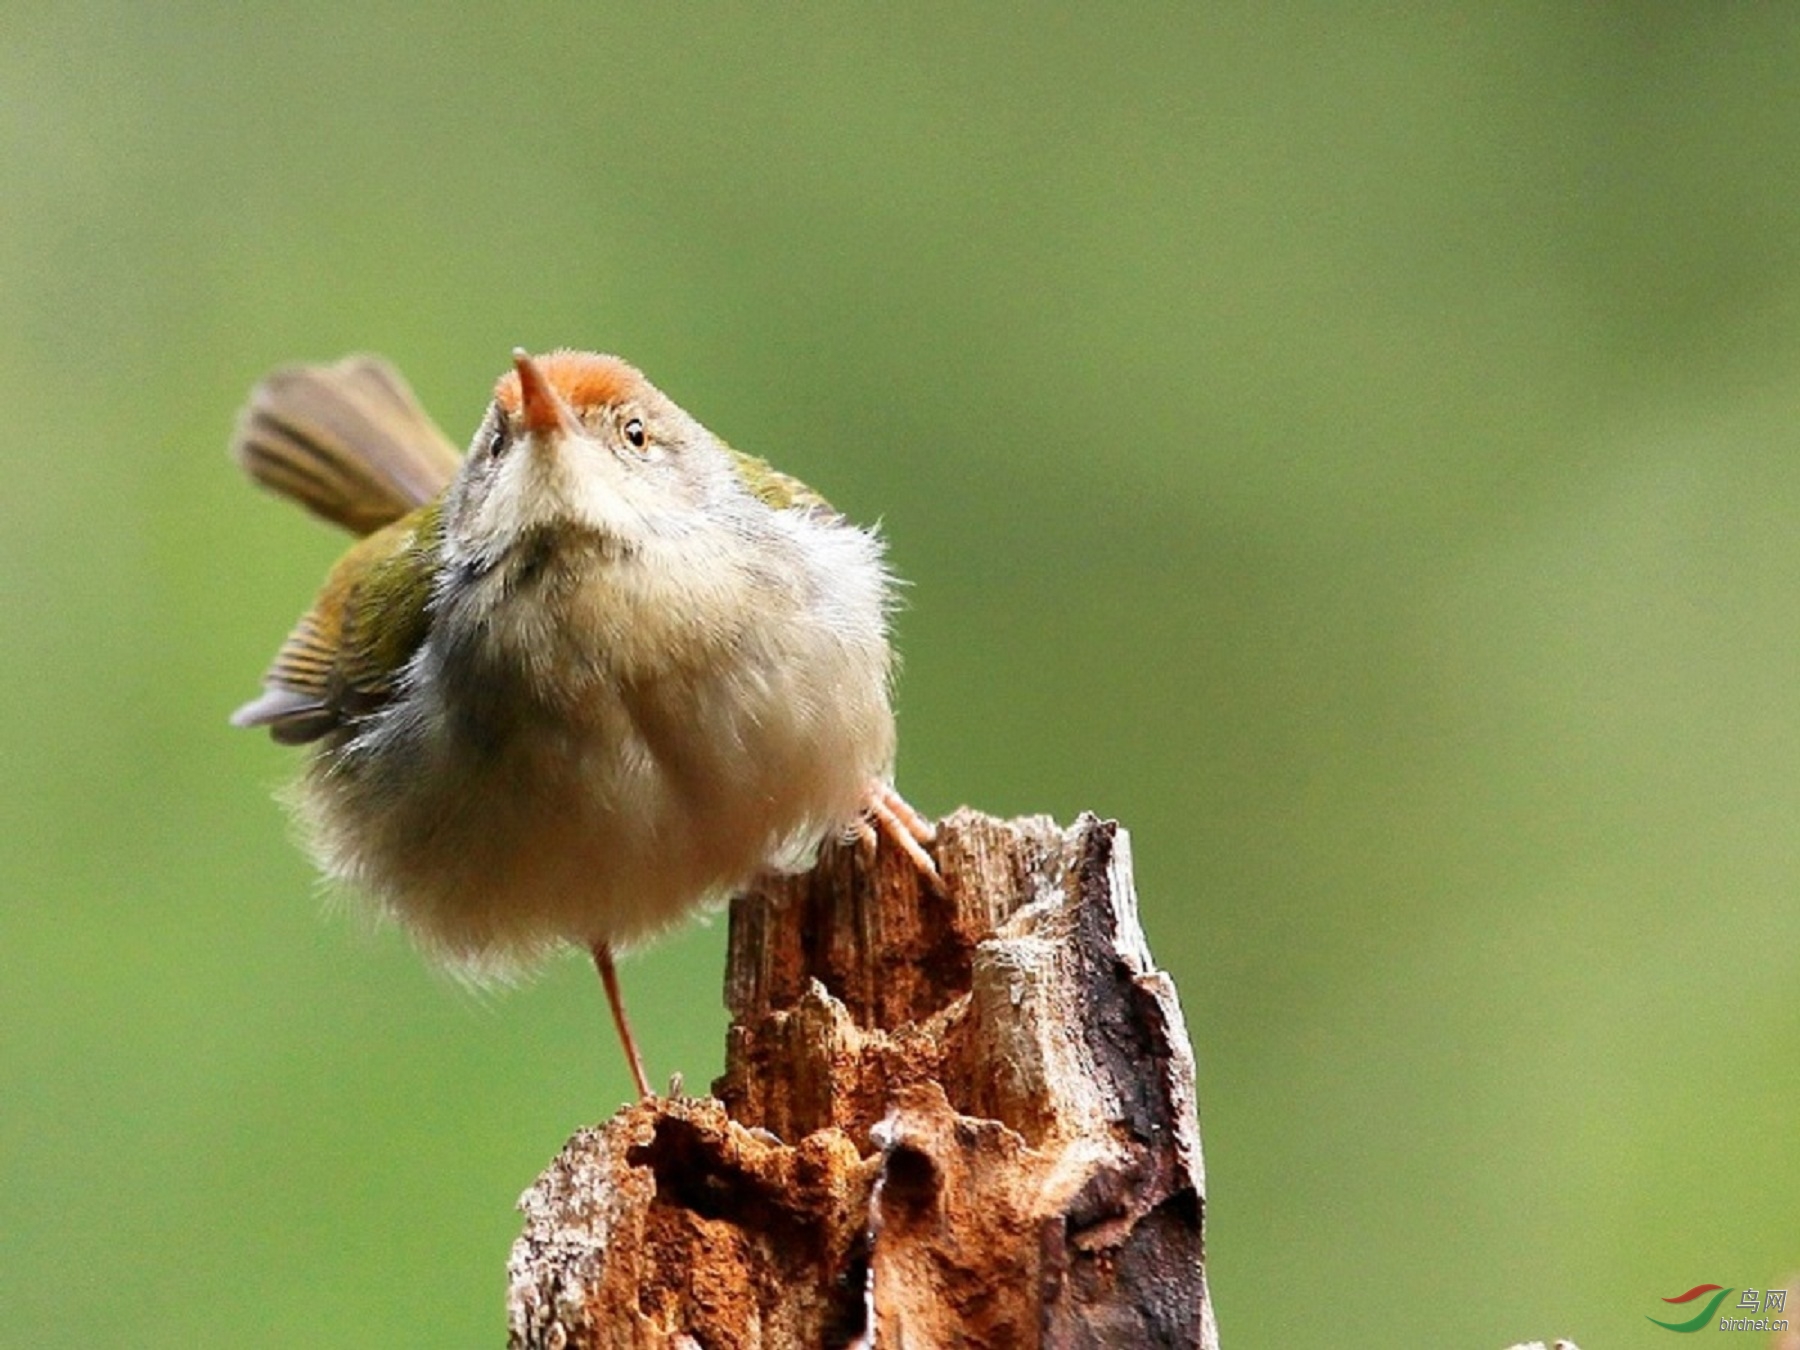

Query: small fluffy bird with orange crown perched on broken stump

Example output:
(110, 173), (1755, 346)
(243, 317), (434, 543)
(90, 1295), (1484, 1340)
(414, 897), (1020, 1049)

(232, 349), (938, 1096)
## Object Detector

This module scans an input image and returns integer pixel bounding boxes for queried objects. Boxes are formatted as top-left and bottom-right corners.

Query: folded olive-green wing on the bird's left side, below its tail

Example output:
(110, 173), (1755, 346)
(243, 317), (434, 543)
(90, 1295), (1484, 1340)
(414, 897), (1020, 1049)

(230, 502), (443, 745)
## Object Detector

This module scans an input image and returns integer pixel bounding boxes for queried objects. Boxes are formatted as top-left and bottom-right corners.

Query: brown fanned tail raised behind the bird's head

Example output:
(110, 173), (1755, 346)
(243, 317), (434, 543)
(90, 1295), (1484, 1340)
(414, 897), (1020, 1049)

(232, 356), (461, 535)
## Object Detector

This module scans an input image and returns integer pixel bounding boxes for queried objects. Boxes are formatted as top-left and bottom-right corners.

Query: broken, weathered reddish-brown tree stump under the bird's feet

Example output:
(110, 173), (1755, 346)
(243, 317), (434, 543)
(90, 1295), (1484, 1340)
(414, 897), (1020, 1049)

(508, 810), (1219, 1350)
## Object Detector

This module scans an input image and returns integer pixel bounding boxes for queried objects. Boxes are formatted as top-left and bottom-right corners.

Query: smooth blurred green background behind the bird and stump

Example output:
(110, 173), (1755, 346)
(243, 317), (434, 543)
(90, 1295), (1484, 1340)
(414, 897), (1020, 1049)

(0, 0), (1800, 1350)
